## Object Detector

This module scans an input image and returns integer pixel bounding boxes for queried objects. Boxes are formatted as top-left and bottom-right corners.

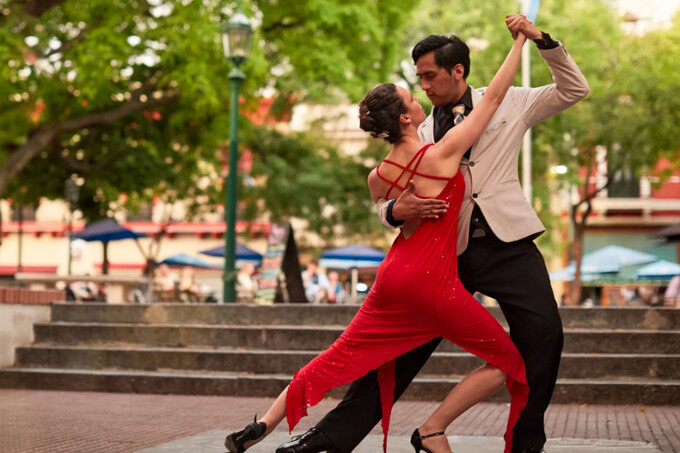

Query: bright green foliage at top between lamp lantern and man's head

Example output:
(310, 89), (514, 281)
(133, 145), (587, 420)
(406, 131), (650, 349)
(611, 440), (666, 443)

(253, 0), (419, 103)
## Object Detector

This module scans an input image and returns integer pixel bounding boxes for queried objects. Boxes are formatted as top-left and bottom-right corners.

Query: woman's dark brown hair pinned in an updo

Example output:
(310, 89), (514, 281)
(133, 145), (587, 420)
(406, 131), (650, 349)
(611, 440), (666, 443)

(359, 83), (407, 143)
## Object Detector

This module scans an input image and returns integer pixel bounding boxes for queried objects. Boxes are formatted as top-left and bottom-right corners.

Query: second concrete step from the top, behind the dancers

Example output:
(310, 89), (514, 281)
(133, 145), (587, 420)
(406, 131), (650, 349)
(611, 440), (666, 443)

(34, 322), (680, 354)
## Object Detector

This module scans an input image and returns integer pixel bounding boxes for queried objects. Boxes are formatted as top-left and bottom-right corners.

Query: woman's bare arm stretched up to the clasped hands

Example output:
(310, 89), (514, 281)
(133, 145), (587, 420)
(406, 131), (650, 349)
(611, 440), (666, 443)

(433, 28), (526, 157)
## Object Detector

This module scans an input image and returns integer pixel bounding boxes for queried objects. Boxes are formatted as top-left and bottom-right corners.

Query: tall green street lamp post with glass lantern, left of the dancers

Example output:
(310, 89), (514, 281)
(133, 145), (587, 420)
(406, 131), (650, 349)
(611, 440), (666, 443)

(222, 11), (253, 303)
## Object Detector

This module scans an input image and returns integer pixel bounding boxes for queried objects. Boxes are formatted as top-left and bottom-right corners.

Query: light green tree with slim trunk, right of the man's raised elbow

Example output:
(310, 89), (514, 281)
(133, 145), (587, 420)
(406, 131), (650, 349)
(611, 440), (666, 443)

(535, 0), (680, 302)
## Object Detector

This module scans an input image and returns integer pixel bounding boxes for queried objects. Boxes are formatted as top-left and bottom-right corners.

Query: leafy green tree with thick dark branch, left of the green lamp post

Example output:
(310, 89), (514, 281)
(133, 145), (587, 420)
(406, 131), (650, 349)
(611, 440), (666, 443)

(0, 0), (234, 218)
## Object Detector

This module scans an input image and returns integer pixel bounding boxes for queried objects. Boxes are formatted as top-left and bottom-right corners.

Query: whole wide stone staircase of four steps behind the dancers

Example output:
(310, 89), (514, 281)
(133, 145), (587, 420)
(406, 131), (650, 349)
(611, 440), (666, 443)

(0, 304), (680, 405)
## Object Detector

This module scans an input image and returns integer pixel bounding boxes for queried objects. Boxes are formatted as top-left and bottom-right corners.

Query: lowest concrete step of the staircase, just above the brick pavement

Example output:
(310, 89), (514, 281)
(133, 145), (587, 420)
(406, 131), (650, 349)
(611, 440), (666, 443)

(0, 368), (680, 405)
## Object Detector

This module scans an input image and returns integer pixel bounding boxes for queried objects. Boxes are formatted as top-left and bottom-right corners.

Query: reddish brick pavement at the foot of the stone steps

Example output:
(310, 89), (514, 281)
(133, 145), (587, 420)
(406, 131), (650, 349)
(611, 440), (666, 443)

(0, 389), (680, 453)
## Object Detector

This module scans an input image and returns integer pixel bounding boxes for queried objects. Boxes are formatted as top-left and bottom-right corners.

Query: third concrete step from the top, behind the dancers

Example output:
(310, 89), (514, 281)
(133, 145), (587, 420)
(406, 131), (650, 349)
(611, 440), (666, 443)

(16, 345), (680, 379)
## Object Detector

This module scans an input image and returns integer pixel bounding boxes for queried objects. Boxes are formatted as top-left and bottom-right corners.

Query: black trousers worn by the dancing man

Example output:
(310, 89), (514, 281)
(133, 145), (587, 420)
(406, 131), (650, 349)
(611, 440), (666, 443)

(317, 234), (564, 453)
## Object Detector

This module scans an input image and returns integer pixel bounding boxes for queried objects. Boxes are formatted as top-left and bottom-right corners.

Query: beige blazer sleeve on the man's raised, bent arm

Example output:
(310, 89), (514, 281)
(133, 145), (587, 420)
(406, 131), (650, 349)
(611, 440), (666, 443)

(512, 44), (589, 127)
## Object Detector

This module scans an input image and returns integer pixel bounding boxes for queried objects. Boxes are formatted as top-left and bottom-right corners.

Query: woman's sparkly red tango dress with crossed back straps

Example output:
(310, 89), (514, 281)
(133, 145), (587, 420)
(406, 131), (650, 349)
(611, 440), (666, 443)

(286, 145), (529, 453)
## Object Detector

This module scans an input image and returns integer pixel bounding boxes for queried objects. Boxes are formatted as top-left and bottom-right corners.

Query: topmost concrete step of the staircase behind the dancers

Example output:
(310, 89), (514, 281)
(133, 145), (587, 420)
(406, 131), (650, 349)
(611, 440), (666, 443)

(52, 303), (680, 330)
